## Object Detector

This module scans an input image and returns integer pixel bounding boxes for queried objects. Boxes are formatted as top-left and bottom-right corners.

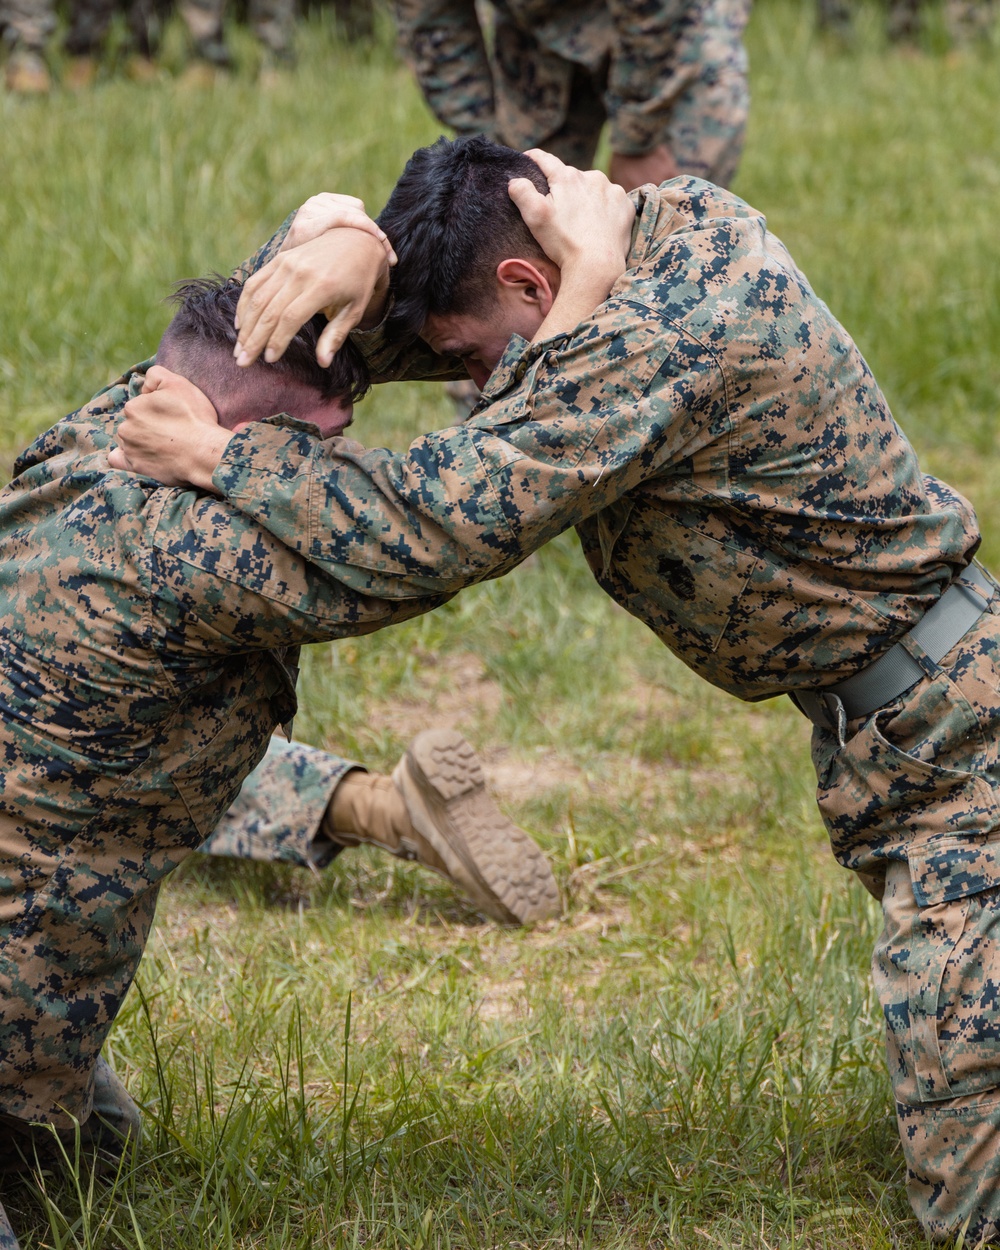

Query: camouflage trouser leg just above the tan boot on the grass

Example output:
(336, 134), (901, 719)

(201, 738), (360, 868)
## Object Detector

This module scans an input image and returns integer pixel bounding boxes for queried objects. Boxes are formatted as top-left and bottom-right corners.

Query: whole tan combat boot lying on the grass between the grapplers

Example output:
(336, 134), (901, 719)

(324, 729), (561, 924)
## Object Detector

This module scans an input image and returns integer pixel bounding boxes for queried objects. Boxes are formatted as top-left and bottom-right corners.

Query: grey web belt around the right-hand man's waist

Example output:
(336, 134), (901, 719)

(789, 564), (996, 730)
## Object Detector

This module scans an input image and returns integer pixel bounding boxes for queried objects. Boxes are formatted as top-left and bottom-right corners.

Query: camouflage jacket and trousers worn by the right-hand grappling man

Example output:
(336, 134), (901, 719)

(177, 148), (1000, 1244)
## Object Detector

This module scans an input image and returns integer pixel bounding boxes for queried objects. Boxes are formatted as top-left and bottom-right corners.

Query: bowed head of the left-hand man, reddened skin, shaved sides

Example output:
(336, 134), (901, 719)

(156, 275), (370, 436)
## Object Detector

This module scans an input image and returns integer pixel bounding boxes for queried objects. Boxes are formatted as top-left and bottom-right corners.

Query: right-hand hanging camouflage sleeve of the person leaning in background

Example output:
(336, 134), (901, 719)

(605, 0), (714, 156)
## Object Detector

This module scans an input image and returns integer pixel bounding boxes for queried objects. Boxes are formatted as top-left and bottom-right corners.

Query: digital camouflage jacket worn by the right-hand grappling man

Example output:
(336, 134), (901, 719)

(208, 179), (985, 889)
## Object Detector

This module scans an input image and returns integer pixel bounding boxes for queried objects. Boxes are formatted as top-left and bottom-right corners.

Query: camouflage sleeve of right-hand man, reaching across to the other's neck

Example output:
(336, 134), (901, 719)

(215, 301), (726, 600)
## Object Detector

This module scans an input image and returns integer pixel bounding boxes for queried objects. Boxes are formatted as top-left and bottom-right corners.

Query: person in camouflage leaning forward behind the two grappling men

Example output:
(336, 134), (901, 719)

(395, 0), (750, 185)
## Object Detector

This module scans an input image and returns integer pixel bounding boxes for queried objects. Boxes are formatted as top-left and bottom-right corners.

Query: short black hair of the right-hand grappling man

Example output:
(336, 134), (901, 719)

(379, 135), (549, 339)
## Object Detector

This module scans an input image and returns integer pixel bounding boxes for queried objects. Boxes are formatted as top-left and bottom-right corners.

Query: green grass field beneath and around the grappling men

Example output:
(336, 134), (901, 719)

(0, 0), (1000, 1250)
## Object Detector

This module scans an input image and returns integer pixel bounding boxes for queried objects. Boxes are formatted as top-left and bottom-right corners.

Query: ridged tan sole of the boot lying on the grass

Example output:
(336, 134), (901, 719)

(400, 729), (563, 924)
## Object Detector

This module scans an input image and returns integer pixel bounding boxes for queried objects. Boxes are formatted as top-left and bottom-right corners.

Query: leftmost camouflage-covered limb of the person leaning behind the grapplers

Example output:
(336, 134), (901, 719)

(394, 0), (494, 135)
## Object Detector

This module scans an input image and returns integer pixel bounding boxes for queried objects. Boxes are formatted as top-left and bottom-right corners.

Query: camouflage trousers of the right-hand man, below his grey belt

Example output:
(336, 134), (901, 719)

(813, 595), (1000, 1246)
